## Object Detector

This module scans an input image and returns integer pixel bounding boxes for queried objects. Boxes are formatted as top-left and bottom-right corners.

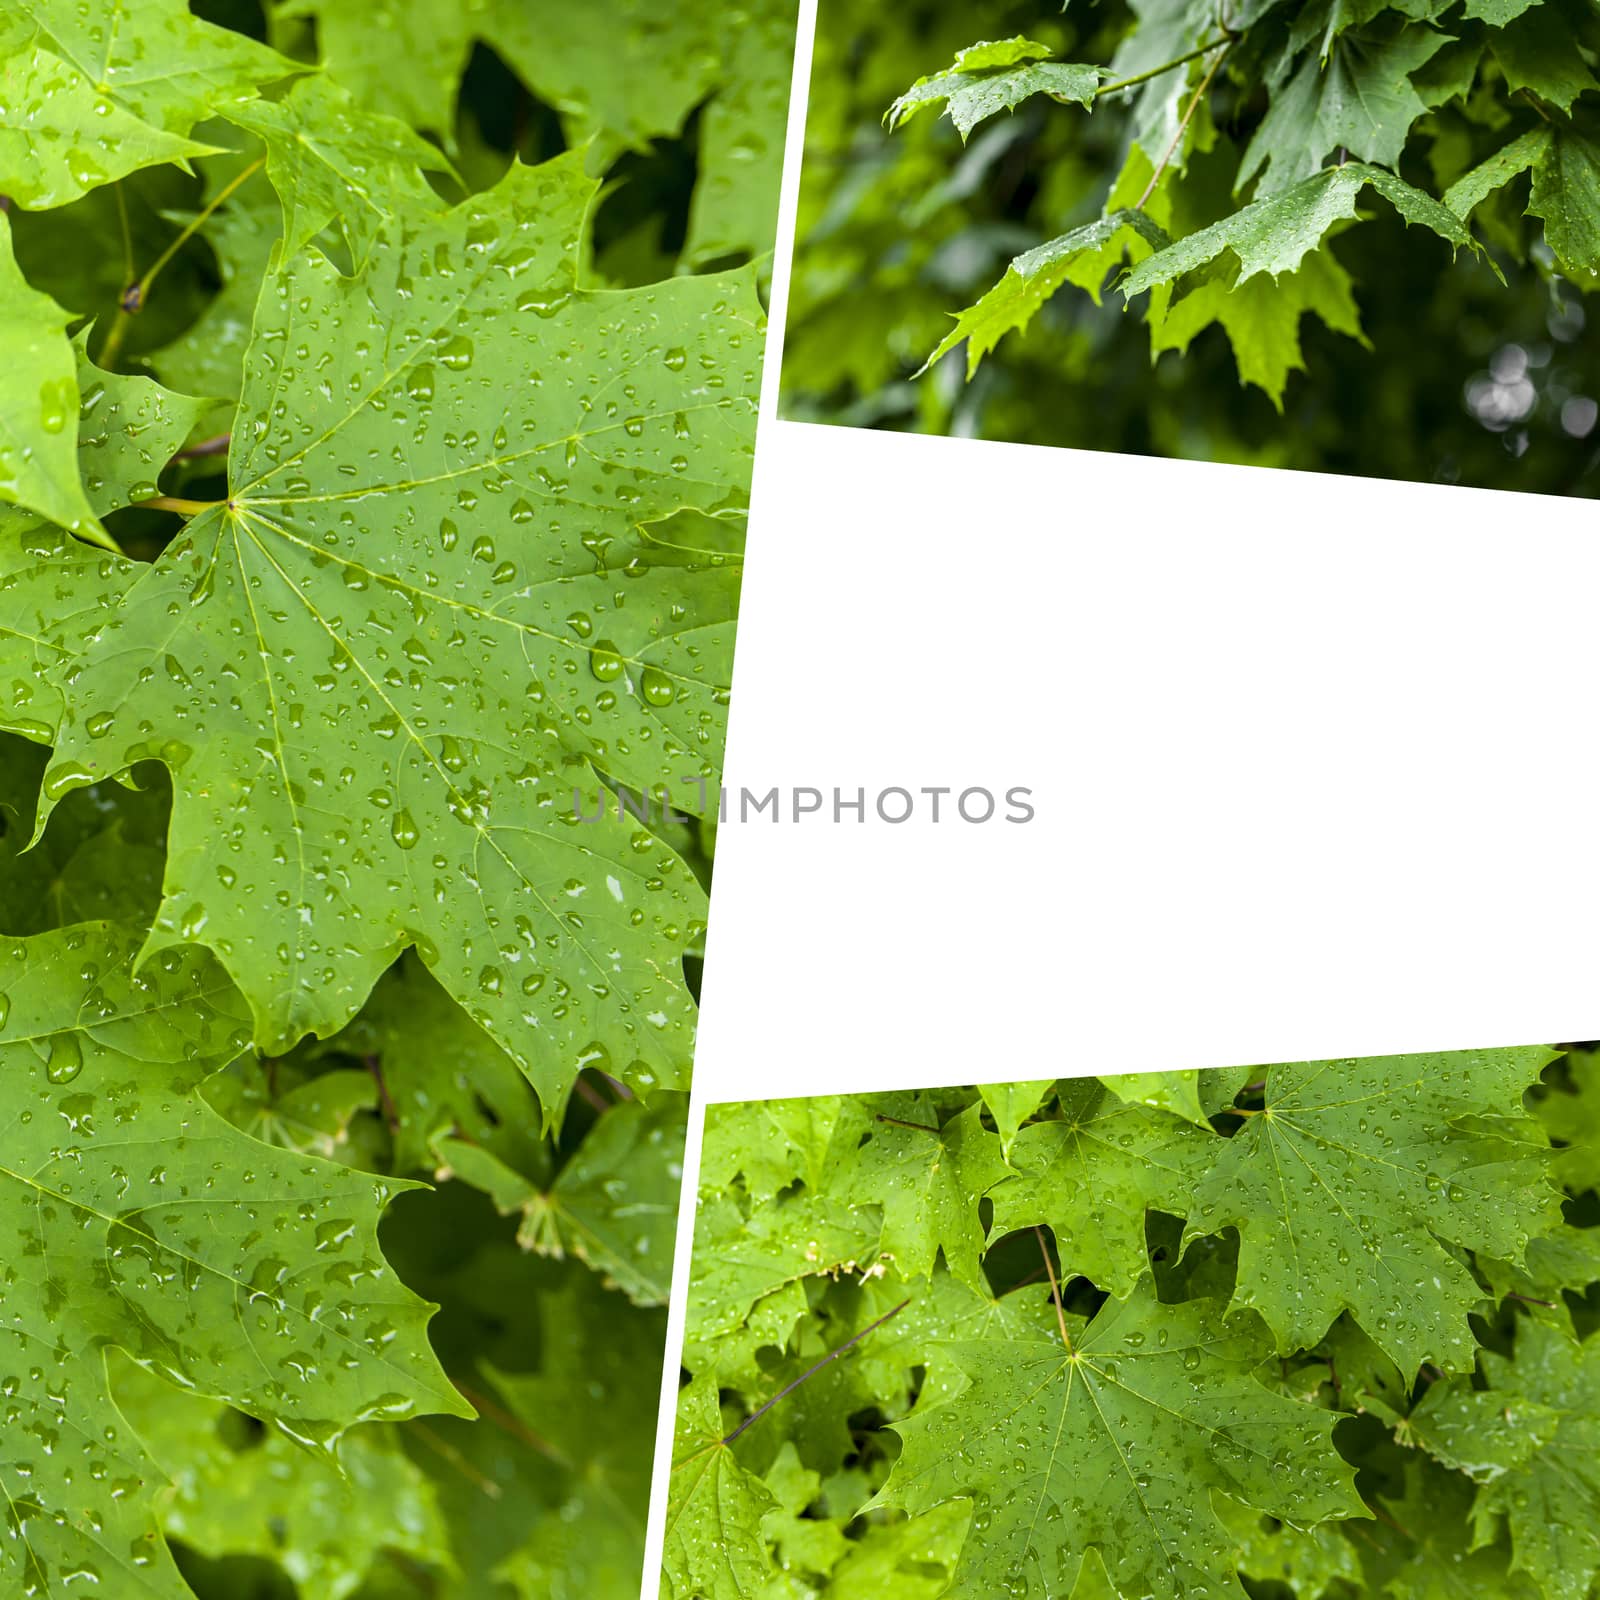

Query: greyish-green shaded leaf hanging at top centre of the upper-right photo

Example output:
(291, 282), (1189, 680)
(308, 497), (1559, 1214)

(1234, 24), (1448, 198)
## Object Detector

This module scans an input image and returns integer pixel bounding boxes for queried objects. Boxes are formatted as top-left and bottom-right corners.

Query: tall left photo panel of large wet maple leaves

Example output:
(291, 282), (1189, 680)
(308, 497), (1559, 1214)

(0, 0), (795, 1600)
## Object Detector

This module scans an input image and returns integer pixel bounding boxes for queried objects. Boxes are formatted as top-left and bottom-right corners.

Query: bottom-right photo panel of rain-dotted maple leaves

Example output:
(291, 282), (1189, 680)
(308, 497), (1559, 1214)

(662, 1046), (1600, 1600)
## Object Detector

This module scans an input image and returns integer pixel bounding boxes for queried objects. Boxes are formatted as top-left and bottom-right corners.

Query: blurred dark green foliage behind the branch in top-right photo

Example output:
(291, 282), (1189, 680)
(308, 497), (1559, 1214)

(782, 0), (1600, 496)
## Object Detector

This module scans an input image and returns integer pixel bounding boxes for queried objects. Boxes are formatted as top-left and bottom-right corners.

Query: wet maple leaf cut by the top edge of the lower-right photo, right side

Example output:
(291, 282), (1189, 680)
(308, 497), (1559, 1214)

(1186, 1050), (1558, 1374)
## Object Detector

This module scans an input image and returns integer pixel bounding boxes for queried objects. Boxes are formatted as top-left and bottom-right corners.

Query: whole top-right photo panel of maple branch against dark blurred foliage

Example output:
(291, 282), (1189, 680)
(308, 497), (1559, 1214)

(784, 0), (1600, 493)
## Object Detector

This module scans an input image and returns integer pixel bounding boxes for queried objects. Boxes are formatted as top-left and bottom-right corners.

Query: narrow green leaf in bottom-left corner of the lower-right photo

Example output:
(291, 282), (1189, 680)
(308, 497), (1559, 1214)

(661, 1376), (778, 1600)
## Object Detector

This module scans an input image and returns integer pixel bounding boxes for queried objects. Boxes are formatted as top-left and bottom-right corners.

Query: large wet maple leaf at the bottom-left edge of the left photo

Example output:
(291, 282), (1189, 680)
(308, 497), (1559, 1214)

(0, 923), (466, 1600)
